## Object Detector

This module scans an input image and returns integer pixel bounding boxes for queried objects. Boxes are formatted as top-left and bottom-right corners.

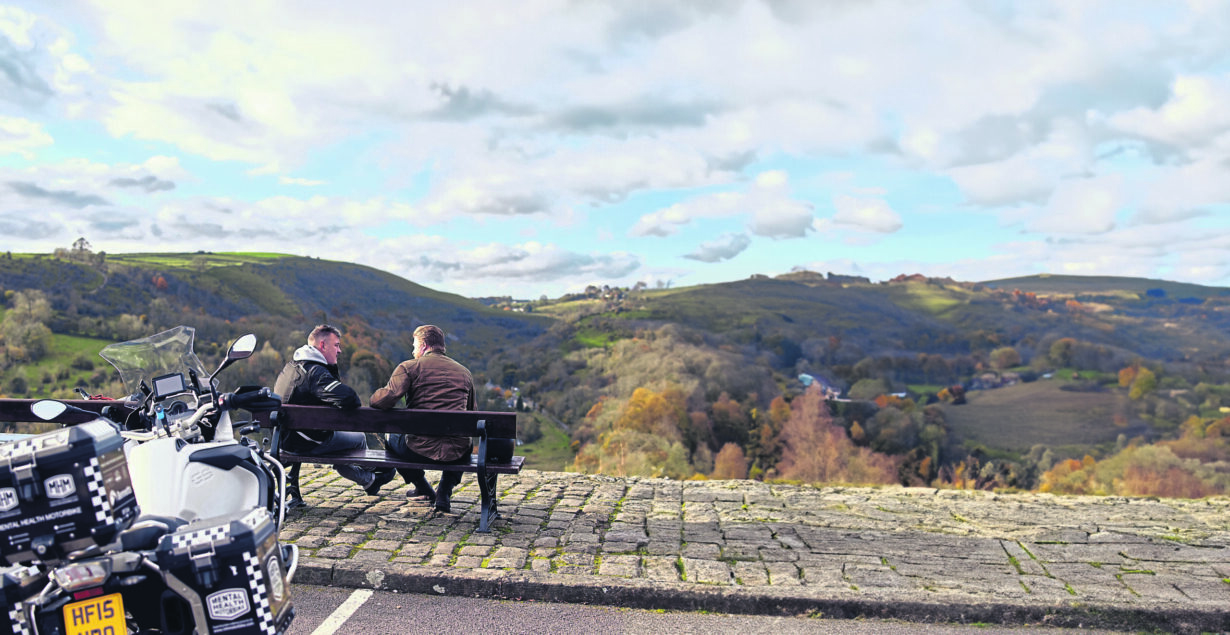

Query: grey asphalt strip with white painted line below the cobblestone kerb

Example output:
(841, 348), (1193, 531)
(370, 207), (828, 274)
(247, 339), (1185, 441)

(282, 585), (1112, 635)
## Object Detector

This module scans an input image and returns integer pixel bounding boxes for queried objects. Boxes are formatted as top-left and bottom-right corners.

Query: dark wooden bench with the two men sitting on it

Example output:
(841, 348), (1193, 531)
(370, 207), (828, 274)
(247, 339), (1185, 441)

(256, 405), (525, 533)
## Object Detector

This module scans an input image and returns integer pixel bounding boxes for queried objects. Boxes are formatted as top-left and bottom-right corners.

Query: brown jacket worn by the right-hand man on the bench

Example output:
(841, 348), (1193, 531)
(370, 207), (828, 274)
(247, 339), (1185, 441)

(371, 351), (475, 461)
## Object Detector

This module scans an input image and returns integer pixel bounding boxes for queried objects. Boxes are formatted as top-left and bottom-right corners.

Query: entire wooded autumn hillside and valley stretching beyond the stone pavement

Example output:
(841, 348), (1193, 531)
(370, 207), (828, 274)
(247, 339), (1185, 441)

(0, 254), (1230, 489)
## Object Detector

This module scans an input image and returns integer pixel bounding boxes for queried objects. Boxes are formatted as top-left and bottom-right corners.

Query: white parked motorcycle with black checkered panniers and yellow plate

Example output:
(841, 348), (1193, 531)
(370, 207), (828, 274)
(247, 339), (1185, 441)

(0, 326), (298, 635)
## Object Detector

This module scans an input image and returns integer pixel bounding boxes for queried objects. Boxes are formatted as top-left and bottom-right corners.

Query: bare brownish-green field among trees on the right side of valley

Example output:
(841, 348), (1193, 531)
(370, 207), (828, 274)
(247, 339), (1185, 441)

(945, 380), (1145, 455)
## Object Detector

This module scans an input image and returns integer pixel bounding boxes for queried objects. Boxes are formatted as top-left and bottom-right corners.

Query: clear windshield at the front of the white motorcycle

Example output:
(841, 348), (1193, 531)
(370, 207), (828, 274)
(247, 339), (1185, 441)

(98, 326), (209, 395)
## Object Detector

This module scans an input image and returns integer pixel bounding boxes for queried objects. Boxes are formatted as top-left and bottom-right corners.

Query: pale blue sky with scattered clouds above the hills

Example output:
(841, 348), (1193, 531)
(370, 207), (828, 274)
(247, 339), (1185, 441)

(0, 0), (1230, 299)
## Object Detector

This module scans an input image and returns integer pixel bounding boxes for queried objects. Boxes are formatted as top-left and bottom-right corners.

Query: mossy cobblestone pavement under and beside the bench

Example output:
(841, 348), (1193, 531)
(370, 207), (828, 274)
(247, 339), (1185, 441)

(282, 465), (1230, 631)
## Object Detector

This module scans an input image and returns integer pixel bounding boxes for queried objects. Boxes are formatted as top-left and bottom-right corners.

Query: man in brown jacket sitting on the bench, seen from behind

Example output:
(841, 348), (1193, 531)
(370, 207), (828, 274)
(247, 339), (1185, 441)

(371, 325), (475, 512)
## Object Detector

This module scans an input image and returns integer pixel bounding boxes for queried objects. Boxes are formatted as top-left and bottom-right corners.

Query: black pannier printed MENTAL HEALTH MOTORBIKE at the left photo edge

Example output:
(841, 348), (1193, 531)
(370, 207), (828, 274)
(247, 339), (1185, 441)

(0, 420), (138, 565)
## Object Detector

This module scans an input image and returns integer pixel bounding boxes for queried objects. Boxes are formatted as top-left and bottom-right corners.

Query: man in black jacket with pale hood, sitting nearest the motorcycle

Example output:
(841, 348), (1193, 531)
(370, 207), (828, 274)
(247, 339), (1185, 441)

(273, 324), (395, 509)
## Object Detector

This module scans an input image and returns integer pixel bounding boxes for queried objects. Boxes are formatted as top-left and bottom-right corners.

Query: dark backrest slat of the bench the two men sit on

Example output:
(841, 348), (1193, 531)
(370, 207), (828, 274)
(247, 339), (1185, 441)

(256, 404), (517, 439)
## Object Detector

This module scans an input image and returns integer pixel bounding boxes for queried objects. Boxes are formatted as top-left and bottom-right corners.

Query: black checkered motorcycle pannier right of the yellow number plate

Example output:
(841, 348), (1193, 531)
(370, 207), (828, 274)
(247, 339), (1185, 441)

(155, 509), (294, 635)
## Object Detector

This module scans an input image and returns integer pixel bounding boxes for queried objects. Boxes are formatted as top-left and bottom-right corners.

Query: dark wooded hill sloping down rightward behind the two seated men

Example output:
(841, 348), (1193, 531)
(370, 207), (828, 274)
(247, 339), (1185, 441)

(0, 254), (547, 359)
